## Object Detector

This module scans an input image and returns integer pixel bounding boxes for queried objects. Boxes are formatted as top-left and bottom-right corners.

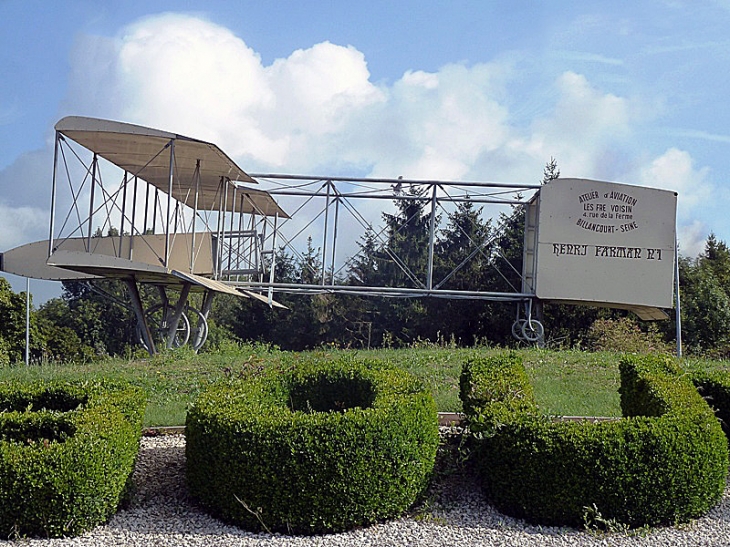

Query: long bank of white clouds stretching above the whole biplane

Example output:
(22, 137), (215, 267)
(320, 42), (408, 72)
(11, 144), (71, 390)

(11, 14), (711, 266)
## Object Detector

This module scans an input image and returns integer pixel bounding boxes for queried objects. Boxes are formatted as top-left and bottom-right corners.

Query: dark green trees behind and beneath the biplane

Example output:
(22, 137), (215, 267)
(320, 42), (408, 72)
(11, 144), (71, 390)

(0, 159), (730, 364)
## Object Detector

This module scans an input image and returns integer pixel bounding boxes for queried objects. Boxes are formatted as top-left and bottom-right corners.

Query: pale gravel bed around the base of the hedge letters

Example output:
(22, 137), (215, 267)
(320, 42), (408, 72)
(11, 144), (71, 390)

(5, 435), (730, 547)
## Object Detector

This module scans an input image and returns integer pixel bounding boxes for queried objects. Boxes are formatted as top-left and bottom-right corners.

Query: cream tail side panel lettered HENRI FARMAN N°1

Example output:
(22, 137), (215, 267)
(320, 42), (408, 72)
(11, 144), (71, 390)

(535, 178), (677, 308)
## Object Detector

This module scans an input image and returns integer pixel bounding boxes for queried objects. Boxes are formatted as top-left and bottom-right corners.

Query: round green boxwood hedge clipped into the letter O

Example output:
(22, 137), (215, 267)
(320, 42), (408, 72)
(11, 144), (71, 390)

(185, 359), (438, 534)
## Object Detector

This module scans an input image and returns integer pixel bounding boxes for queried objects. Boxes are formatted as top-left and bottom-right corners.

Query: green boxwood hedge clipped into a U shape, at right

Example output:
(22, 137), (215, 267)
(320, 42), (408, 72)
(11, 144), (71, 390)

(461, 355), (728, 526)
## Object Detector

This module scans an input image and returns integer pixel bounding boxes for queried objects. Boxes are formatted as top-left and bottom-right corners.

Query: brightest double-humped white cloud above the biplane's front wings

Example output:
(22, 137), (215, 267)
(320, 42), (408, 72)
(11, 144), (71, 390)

(73, 14), (382, 170)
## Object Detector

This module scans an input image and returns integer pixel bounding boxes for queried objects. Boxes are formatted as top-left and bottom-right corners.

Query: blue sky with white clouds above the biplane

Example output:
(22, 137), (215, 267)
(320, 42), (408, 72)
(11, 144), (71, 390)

(0, 0), (730, 302)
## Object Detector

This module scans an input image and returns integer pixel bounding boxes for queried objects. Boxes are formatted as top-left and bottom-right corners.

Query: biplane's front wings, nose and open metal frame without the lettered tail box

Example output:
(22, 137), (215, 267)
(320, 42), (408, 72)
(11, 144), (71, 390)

(11, 117), (676, 353)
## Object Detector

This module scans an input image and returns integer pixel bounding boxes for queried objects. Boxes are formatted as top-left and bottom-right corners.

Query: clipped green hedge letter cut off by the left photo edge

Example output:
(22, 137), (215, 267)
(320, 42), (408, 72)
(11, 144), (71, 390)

(0, 382), (146, 538)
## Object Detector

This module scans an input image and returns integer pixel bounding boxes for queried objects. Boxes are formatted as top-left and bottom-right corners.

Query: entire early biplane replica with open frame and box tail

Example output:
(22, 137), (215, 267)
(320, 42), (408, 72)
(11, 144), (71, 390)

(0, 116), (676, 354)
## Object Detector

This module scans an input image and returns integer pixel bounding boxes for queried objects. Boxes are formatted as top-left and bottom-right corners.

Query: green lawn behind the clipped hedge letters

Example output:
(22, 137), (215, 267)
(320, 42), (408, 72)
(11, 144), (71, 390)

(0, 345), (730, 426)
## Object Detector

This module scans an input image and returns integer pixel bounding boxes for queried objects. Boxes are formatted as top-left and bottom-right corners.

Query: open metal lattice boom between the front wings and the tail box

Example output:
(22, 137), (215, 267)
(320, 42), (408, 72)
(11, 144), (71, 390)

(233, 174), (540, 301)
